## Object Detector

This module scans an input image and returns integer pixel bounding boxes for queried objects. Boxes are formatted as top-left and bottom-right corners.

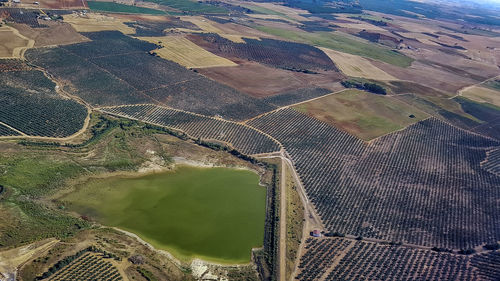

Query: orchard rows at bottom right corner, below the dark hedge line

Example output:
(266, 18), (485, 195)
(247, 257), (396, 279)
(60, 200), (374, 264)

(296, 238), (500, 281)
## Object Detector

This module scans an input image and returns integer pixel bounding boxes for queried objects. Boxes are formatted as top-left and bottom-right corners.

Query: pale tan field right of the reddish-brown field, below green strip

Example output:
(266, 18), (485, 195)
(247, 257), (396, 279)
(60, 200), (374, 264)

(320, 48), (398, 80)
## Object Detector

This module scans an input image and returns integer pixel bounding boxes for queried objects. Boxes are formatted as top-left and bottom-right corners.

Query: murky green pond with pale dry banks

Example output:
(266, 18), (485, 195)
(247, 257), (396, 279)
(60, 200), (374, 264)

(60, 166), (266, 263)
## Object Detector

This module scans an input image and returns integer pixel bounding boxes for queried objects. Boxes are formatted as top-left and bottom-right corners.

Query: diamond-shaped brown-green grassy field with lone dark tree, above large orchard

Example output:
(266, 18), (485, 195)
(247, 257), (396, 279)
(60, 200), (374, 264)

(295, 90), (429, 141)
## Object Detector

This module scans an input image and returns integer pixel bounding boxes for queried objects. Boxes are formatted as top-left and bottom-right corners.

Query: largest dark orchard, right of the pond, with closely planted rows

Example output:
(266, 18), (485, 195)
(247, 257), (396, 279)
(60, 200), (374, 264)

(248, 109), (500, 249)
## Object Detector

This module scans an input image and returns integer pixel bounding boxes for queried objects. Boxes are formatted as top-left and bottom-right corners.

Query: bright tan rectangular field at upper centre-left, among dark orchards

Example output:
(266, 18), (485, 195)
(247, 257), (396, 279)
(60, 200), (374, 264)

(139, 36), (237, 68)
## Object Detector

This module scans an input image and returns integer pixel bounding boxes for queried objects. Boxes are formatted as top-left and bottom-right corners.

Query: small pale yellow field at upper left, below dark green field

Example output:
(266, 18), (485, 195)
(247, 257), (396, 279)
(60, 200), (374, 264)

(64, 13), (135, 34)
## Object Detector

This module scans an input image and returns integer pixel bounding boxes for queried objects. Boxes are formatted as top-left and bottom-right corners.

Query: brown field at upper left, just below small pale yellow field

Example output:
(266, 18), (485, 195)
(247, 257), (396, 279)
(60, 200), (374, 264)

(13, 21), (89, 47)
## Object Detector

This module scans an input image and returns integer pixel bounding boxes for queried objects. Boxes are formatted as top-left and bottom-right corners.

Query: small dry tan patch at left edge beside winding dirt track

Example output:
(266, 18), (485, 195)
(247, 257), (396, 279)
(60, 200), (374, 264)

(0, 26), (33, 58)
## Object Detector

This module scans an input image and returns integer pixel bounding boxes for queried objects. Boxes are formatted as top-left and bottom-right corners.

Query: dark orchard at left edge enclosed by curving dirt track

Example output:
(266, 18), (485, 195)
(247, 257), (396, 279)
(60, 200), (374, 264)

(0, 70), (87, 137)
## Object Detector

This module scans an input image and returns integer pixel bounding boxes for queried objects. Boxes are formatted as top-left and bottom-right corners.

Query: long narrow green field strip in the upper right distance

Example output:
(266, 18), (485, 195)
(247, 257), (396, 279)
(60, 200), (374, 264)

(256, 26), (414, 67)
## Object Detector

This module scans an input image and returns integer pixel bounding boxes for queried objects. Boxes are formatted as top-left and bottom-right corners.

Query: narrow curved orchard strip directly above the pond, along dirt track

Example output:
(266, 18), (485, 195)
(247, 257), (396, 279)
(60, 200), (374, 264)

(101, 105), (280, 155)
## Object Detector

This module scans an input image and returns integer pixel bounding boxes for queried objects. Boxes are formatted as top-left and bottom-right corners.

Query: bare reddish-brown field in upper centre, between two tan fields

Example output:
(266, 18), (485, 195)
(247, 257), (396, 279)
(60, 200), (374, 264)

(198, 61), (342, 98)
